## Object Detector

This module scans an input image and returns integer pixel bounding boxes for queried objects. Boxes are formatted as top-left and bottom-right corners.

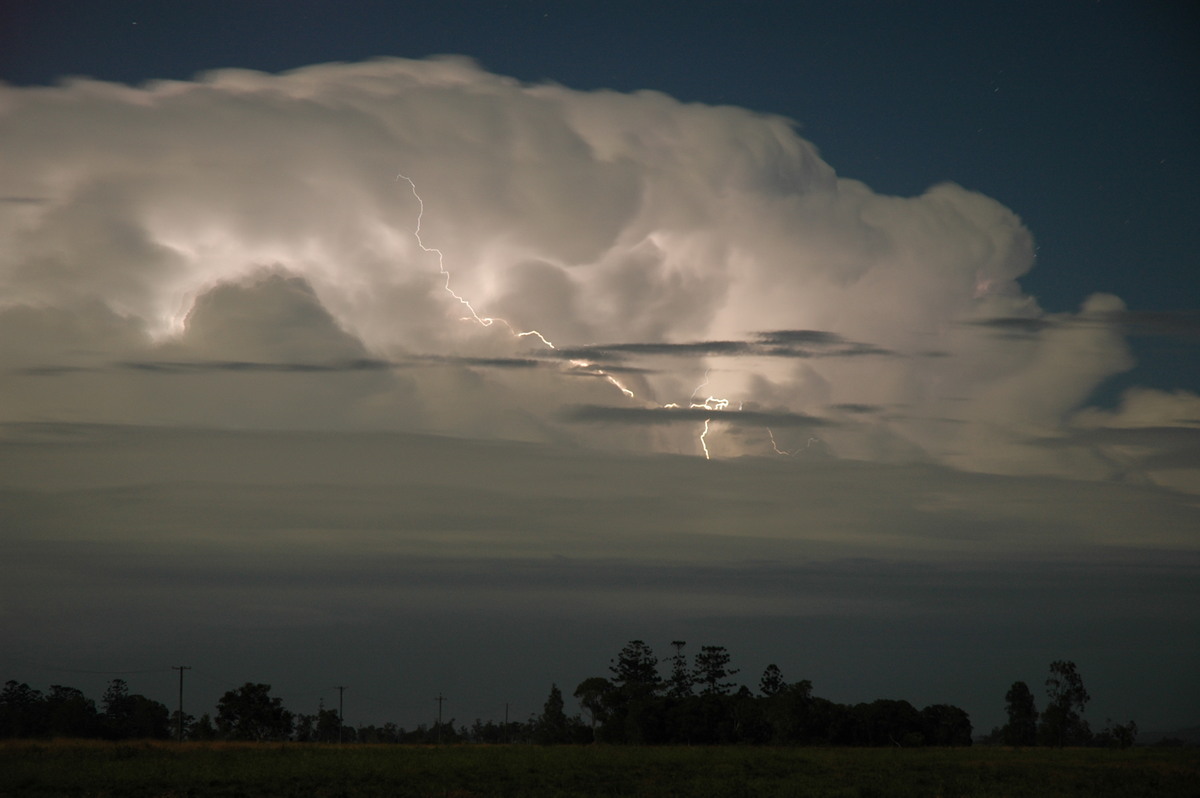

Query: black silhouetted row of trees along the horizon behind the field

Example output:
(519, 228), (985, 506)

(0, 640), (1136, 748)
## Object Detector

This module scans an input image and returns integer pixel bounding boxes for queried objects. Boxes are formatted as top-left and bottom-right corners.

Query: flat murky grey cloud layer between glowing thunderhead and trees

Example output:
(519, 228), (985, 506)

(0, 420), (1200, 732)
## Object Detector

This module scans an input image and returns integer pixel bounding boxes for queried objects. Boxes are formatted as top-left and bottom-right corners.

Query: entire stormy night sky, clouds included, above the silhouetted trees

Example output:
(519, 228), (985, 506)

(0, 0), (1200, 732)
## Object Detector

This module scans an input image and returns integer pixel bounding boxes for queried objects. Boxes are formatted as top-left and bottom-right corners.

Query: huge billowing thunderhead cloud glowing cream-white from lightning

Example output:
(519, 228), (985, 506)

(0, 58), (1195, 484)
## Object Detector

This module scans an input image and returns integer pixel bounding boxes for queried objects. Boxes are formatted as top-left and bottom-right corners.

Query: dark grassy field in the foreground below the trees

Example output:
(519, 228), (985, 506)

(0, 740), (1200, 798)
